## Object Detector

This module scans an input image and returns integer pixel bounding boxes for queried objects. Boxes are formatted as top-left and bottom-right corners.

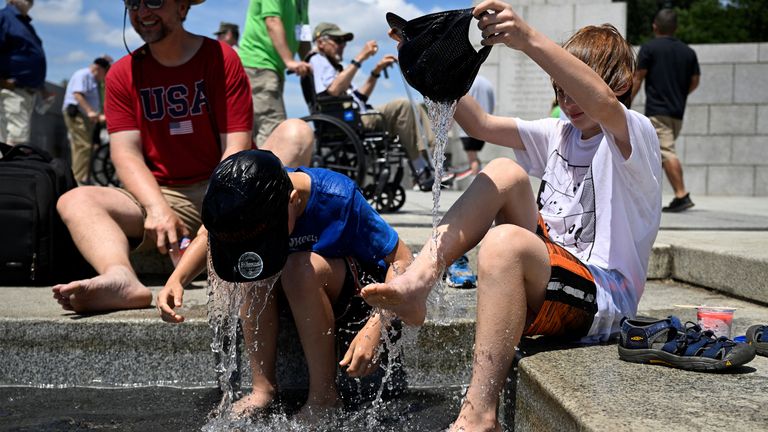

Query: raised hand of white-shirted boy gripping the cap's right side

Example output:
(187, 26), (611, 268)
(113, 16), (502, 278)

(473, 0), (534, 50)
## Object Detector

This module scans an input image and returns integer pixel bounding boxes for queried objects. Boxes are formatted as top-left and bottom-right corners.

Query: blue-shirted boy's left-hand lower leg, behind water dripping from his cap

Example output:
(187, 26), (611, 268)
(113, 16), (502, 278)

(237, 284), (279, 413)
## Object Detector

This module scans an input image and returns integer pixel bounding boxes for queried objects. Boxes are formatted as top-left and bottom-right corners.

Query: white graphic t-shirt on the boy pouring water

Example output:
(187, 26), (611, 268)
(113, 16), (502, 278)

(515, 108), (662, 342)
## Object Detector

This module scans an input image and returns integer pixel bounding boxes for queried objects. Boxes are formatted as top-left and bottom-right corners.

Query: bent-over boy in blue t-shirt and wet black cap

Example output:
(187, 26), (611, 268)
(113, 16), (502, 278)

(157, 150), (412, 418)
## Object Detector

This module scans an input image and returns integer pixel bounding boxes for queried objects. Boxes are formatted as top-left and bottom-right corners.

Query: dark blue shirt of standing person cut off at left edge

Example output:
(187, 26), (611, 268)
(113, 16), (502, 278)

(0, 4), (46, 88)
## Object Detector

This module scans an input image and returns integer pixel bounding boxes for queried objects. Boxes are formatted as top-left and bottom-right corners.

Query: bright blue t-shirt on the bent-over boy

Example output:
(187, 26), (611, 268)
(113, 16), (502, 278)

(286, 167), (398, 267)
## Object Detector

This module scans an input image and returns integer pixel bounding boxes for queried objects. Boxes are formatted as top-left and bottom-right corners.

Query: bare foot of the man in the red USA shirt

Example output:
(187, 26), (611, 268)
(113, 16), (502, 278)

(53, 267), (152, 312)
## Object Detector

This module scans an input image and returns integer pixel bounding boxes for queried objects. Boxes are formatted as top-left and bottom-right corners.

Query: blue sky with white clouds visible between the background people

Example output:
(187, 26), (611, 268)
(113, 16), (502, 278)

(30, 0), (472, 117)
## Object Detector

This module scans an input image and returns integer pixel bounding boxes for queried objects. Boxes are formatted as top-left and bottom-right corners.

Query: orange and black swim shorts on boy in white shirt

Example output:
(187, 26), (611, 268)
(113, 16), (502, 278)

(523, 215), (597, 340)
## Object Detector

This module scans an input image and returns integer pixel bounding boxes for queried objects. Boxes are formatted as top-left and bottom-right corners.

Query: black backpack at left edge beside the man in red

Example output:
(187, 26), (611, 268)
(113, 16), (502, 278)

(0, 143), (90, 286)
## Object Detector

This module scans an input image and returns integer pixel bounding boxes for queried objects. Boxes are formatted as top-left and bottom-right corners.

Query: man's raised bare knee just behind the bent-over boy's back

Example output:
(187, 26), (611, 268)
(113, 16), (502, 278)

(261, 119), (315, 168)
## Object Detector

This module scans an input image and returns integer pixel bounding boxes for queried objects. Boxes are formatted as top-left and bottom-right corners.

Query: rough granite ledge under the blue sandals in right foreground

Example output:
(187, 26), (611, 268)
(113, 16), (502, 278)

(507, 282), (768, 432)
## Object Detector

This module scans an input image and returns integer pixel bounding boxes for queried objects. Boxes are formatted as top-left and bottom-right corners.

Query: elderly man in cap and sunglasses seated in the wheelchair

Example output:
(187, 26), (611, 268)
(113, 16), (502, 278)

(305, 22), (453, 191)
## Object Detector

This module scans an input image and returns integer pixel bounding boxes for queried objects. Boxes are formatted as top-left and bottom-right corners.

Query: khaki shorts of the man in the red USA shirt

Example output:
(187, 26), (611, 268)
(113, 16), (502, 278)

(115, 181), (208, 251)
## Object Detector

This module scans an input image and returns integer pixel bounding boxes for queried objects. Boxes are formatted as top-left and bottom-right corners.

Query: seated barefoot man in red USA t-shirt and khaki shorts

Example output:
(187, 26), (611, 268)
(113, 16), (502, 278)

(53, 0), (312, 312)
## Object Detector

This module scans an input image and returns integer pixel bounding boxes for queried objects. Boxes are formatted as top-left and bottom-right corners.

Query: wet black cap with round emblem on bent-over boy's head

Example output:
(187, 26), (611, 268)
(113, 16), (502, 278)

(202, 150), (293, 282)
